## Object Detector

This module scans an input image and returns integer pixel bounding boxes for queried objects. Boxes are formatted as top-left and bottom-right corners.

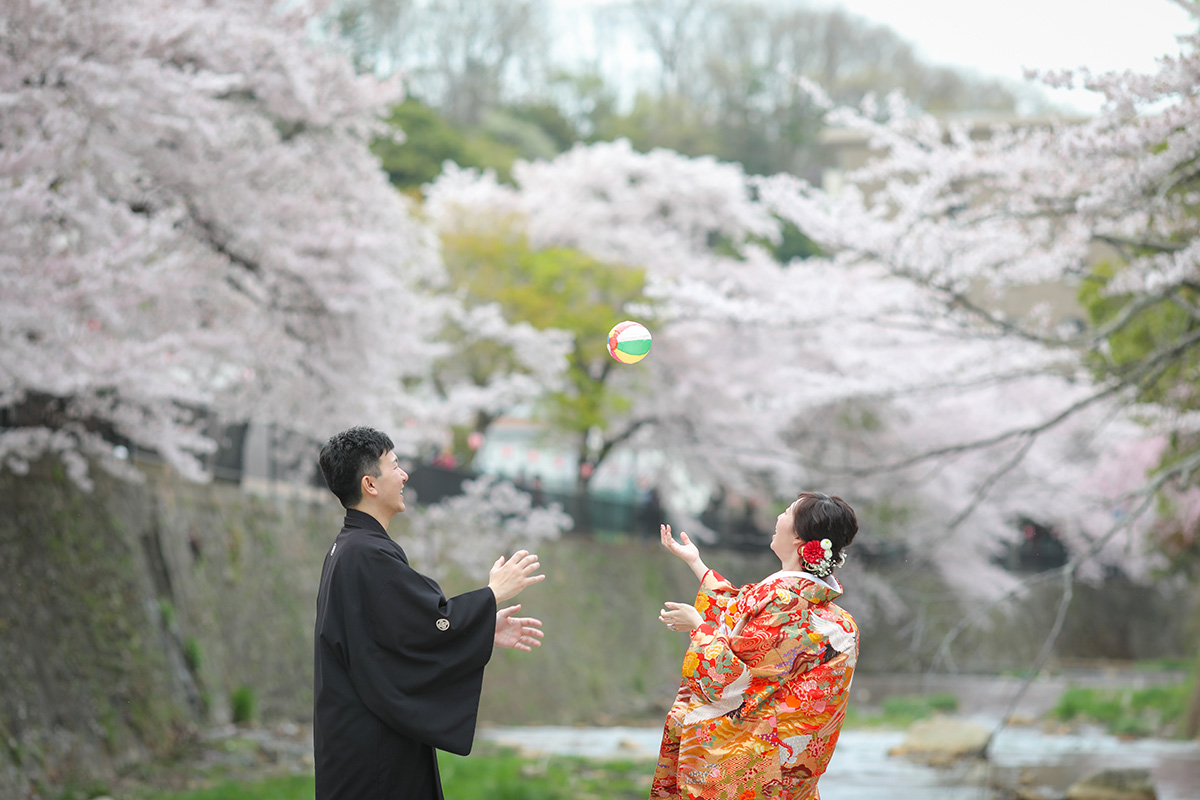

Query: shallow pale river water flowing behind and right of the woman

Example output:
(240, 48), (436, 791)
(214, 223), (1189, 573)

(479, 672), (1200, 800)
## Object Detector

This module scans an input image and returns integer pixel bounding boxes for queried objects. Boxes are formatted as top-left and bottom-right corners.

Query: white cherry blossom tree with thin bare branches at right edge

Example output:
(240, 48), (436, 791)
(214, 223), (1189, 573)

(757, 0), (1200, 735)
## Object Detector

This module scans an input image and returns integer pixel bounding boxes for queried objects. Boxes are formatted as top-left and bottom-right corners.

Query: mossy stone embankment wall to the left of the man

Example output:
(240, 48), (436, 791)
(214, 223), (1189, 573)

(0, 464), (340, 798)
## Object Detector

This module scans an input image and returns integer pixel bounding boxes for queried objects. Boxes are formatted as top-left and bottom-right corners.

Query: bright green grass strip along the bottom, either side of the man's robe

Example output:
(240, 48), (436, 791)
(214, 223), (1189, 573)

(127, 745), (654, 800)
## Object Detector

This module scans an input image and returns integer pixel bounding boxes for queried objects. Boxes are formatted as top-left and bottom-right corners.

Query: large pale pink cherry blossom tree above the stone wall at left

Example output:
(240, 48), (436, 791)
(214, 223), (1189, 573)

(0, 0), (456, 481)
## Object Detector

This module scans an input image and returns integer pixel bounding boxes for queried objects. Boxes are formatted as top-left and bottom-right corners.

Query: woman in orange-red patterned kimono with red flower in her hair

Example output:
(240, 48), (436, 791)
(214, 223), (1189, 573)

(650, 492), (858, 800)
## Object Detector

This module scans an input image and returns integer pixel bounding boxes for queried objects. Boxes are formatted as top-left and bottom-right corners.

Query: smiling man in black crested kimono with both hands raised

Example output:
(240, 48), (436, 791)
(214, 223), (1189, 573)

(313, 427), (545, 800)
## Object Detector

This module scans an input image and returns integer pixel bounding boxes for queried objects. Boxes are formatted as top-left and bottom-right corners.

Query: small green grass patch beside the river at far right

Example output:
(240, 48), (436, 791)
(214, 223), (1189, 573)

(1051, 682), (1192, 736)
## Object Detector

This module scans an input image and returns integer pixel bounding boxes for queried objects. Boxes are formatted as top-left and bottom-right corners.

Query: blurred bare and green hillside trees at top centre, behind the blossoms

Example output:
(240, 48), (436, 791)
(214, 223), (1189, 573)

(338, 0), (1050, 190)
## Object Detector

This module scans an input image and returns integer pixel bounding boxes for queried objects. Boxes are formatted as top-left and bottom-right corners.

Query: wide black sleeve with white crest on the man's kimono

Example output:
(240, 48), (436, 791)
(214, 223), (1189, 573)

(343, 547), (496, 754)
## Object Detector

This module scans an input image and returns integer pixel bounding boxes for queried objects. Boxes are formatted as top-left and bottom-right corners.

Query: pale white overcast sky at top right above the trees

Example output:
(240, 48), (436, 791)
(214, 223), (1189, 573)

(815, 0), (1196, 110)
